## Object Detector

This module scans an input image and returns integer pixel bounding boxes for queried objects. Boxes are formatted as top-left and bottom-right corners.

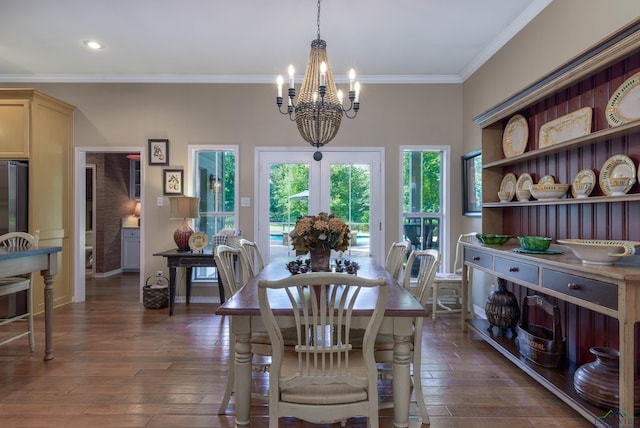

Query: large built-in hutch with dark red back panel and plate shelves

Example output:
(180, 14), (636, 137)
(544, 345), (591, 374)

(464, 21), (640, 426)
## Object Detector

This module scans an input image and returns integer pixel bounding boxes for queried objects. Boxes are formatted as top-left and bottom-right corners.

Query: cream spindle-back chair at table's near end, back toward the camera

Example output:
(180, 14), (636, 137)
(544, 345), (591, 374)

(258, 272), (388, 428)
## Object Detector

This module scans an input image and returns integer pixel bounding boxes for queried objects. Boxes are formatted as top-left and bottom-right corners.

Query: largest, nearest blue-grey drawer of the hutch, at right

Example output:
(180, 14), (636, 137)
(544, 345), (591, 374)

(542, 269), (618, 310)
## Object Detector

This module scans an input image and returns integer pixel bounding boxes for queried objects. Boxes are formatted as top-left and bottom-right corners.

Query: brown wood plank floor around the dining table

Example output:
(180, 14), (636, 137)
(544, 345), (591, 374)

(0, 274), (593, 428)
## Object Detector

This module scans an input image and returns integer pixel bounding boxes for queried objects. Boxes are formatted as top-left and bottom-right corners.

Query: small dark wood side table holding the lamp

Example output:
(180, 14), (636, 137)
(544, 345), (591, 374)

(154, 248), (224, 316)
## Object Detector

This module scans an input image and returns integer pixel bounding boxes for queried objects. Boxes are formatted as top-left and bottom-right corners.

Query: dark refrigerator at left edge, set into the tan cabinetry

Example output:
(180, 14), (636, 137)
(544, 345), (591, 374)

(0, 161), (29, 235)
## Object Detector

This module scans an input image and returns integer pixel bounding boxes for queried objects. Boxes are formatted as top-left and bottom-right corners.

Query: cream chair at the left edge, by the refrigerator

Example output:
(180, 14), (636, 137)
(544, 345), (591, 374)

(0, 232), (37, 352)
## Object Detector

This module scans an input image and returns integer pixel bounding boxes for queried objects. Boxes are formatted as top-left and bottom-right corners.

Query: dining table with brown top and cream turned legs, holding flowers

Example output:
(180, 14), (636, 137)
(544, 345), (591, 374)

(216, 257), (429, 428)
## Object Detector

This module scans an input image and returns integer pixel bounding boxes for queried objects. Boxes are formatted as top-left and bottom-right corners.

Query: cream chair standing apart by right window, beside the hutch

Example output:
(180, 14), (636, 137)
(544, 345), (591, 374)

(431, 232), (477, 321)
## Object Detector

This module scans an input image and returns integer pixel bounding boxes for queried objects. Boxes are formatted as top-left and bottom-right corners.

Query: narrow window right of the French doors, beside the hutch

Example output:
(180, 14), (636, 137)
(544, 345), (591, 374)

(402, 148), (448, 274)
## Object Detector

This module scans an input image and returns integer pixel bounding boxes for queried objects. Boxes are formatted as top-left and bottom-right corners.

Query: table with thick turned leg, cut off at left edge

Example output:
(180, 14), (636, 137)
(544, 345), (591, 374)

(0, 247), (62, 361)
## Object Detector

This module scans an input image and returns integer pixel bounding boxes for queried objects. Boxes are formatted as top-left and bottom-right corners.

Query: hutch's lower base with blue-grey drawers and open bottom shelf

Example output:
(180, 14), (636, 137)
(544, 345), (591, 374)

(462, 241), (640, 427)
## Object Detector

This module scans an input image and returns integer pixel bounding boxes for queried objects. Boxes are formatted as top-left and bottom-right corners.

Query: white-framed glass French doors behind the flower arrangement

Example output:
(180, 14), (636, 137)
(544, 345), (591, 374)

(255, 149), (384, 262)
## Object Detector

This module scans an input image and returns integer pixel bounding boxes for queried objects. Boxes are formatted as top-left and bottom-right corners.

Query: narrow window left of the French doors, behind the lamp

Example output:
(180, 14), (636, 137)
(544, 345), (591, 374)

(193, 146), (238, 280)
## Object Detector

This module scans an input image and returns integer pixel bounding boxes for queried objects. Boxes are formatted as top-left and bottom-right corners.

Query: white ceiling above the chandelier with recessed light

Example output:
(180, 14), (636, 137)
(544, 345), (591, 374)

(0, 0), (552, 83)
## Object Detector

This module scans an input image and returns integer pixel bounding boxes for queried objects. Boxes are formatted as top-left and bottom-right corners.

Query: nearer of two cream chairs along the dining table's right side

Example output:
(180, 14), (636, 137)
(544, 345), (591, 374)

(374, 249), (441, 424)
